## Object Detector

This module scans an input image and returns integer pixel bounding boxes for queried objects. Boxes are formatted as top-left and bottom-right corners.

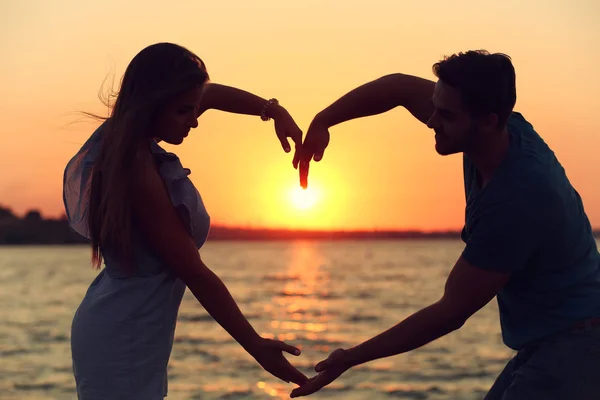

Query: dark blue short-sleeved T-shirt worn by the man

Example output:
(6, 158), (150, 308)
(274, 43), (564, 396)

(462, 112), (600, 350)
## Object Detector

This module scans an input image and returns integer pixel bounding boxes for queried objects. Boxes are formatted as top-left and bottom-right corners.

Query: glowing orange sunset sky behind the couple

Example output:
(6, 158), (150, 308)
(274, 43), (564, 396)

(0, 0), (600, 230)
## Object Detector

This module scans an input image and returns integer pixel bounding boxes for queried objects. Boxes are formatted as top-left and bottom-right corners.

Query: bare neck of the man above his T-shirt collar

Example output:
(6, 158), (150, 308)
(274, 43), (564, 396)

(465, 127), (510, 186)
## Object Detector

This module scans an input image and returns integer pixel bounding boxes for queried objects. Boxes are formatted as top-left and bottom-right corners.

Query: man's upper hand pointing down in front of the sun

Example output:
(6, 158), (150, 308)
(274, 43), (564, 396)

(294, 117), (329, 189)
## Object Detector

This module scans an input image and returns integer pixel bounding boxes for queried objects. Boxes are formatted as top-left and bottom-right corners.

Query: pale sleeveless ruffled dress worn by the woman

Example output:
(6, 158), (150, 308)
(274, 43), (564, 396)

(63, 124), (210, 400)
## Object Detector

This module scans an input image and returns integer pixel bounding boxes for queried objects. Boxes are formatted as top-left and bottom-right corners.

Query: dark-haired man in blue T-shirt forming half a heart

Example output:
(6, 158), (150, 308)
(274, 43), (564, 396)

(292, 51), (600, 400)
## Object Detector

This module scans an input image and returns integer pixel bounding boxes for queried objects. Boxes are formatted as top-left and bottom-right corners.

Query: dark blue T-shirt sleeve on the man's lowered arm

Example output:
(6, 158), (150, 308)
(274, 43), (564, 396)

(462, 193), (548, 273)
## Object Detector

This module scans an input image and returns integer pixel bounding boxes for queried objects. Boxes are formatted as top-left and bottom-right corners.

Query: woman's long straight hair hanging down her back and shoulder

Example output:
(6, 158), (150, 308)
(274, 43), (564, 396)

(87, 43), (208, 270)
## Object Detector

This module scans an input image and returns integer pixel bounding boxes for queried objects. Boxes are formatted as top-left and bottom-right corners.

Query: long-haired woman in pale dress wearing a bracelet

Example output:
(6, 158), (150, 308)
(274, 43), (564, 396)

(63, 43), (307, 400)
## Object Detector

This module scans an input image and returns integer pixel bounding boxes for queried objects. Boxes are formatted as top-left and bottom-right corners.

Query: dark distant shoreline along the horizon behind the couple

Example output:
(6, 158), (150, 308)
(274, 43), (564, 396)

(0, 207), (600, 246)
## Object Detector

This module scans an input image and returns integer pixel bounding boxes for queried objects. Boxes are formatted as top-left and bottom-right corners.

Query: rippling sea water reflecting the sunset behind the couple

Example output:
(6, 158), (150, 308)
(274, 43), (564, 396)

(0, 239), (524, 400)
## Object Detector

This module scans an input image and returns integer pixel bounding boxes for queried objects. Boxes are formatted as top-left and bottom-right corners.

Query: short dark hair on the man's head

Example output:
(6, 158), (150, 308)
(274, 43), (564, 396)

(433, 50), (517, 126)
